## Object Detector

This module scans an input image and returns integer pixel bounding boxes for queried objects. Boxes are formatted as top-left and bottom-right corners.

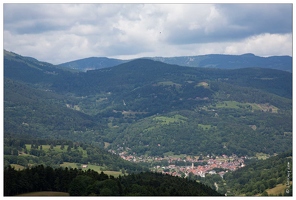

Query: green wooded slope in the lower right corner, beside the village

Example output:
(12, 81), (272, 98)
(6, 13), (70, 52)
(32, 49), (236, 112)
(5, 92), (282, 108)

(225, 151), (293, 196)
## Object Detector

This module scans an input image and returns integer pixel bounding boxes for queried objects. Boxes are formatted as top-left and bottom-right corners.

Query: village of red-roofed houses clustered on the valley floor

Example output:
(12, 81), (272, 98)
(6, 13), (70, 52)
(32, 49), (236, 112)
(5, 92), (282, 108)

(113, 151), (246, 178)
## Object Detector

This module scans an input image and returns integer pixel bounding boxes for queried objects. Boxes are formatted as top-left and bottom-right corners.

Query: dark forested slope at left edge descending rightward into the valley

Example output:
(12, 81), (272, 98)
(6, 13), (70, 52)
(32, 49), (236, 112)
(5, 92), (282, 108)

(4, 78), (104, 146)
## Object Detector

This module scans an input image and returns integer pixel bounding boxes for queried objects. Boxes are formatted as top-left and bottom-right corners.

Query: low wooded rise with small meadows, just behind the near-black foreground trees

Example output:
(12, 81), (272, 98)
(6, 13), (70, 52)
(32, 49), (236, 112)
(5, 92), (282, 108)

(4, 135), (148, 173)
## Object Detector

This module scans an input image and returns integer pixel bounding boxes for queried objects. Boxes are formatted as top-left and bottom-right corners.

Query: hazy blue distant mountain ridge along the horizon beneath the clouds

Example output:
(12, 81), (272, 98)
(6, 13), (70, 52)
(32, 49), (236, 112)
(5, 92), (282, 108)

(59, 53), (292, 72)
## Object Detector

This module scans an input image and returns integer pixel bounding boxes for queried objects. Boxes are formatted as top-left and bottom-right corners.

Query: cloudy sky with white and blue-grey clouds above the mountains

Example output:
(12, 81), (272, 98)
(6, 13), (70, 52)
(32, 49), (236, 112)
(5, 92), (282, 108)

(3, 3), (292, 64)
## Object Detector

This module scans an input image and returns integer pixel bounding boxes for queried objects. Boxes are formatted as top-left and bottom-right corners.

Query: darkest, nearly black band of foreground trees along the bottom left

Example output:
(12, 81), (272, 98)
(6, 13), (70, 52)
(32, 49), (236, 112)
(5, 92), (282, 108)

(4, 165), (222, 196)
